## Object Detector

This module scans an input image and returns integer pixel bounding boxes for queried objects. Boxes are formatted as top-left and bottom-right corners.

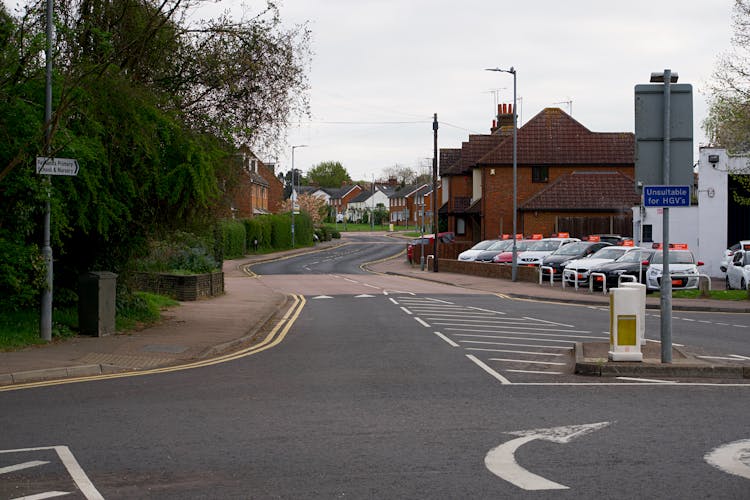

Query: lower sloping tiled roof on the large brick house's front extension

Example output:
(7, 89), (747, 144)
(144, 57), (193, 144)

(519, 172), (641, 211)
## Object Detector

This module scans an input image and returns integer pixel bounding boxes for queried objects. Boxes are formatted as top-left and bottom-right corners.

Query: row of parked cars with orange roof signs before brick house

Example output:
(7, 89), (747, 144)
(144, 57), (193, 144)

(458, 235), (708, 291)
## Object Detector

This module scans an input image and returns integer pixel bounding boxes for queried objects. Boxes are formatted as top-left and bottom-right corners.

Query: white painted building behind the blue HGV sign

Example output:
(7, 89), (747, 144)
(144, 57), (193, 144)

(633, 148), (750, 277)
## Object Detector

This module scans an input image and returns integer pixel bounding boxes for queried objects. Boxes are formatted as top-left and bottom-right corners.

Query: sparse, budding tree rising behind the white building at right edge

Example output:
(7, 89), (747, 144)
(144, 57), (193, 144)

(703, 0), (750, 153)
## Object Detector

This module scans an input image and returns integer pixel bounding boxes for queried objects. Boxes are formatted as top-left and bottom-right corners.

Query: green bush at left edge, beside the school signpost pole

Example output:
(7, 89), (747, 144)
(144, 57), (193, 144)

(0, 231), (47, 311)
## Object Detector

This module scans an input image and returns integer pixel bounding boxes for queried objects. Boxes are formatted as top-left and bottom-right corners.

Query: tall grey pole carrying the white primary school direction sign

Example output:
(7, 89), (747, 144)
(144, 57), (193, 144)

(39, 0), (54, 342)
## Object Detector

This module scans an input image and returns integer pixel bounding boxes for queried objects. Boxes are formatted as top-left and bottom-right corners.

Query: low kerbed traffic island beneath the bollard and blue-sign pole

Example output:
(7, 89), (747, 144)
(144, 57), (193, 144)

(575, 342), (750, 379)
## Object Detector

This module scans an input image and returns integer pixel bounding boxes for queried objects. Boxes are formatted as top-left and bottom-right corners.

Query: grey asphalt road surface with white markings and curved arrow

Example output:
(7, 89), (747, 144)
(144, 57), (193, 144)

(0, 235), (750, 499)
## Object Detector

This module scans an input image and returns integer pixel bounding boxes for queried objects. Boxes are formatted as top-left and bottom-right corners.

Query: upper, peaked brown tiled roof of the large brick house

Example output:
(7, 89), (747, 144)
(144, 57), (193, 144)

(478, 108), (635, 166)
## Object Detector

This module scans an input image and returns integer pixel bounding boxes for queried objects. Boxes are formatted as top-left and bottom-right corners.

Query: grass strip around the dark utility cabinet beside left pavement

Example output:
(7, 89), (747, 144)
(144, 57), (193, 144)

(0, 292), (179, 351)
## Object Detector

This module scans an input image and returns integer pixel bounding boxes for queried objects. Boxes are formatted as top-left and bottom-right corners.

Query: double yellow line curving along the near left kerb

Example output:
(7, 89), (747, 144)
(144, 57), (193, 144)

(0, 294), (307, 392)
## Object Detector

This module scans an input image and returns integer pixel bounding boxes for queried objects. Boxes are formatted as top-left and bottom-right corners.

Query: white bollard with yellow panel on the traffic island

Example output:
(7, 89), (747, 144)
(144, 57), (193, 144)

(609, 288), (643, 361)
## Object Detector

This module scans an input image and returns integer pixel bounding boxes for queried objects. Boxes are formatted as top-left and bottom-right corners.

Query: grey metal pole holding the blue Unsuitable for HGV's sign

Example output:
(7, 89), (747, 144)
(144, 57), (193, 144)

(660, 69), (672, 363)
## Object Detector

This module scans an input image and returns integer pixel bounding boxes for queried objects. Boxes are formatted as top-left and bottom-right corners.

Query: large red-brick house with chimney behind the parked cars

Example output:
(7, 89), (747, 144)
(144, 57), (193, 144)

(441, 105), (637, 241)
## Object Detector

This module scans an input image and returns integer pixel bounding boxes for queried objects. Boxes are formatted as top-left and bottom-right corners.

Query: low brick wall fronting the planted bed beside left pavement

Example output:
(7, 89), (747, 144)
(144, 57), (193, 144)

(130, 271), (224, 301)
